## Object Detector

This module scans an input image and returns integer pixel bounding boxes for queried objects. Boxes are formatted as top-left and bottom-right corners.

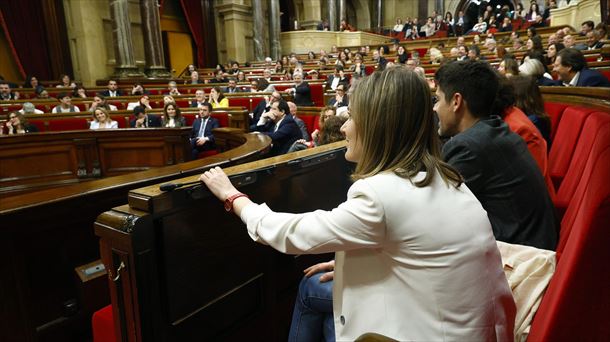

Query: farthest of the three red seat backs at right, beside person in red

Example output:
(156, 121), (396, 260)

(549, 107), (595, 189)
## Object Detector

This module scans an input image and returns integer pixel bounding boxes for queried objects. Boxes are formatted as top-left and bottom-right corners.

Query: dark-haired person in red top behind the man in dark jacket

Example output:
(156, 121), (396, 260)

(491, 78), (553, 182)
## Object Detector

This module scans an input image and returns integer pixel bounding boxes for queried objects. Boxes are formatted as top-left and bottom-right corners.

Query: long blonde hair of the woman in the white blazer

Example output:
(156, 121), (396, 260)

(350, 67), (463, 187)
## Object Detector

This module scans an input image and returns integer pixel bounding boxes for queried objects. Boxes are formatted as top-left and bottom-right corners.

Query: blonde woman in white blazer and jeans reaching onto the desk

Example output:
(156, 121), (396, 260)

(200, 68), (515, 341)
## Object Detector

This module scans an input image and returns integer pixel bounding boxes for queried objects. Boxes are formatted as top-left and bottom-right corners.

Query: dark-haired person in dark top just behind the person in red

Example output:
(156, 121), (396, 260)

(510, 76), (551, 145)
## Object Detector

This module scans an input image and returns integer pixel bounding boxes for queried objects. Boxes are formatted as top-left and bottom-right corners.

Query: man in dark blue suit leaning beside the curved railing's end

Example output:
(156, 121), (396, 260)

(251, 100), (301, 156)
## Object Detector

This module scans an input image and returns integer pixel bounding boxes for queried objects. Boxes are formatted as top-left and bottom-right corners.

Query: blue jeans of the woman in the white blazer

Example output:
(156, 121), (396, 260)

(288, 272), (335, 342)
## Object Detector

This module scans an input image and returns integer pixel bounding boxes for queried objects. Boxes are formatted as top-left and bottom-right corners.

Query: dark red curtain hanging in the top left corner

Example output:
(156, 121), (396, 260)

(0, 0), (52, 80)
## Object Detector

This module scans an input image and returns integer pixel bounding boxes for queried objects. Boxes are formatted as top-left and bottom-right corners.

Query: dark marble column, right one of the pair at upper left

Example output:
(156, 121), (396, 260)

(140, 0), (171, 78)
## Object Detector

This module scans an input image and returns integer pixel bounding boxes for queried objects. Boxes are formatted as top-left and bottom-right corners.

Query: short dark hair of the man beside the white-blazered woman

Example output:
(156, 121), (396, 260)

(434, 60), (500, 117)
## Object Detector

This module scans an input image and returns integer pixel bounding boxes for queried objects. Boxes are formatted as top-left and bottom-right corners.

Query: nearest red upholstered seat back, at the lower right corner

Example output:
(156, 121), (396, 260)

(528, 145), (610, 341)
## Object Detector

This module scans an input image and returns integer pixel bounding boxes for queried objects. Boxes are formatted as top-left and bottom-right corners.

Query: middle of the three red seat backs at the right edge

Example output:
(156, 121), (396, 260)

(555, 112), (610, 218)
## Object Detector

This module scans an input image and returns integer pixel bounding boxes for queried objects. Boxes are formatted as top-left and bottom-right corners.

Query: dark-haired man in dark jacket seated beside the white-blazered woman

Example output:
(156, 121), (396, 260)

(434, 61), (559, 250)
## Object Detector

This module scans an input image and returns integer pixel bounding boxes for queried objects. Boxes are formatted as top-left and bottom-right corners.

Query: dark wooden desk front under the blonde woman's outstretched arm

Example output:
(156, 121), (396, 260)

(95, 143), (351, 341)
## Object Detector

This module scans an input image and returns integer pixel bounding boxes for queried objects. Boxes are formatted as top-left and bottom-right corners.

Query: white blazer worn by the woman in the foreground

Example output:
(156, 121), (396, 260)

(241, 172), (515, 341)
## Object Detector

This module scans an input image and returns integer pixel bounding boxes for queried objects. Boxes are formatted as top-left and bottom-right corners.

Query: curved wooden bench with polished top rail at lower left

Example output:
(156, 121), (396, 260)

(0, 129), (271, 341)
